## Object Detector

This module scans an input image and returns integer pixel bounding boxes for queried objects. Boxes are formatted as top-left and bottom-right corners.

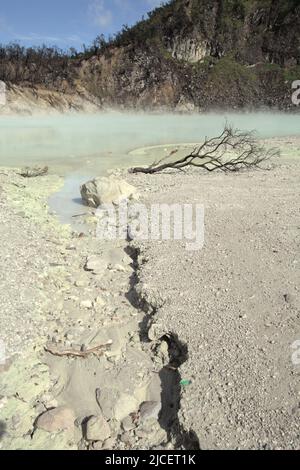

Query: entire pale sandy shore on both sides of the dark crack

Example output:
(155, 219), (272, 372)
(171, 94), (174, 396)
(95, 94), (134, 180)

(0, 138), (300, 449)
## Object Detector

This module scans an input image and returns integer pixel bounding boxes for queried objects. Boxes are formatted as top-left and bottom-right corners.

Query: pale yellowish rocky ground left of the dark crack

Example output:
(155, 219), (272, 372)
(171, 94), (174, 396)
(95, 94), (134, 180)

(0, 171), (167, 450)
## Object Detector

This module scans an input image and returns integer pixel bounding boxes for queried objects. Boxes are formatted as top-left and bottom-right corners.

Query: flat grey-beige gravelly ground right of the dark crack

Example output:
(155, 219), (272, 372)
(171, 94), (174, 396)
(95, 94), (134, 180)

(125, 139), (300, 449)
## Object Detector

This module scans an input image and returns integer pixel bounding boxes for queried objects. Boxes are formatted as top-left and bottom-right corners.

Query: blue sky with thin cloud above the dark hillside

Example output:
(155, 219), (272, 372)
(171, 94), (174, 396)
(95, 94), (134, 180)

(0, 0), (161, 49)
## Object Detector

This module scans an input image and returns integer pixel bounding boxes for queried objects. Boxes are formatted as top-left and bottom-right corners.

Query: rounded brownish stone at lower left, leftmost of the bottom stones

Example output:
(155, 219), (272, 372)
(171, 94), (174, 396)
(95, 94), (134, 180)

(36, 406), (75, 433)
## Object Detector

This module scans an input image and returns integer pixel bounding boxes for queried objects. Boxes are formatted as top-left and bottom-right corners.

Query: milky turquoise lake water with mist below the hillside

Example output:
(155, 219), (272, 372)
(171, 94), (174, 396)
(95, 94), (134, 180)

(0, 112), (300, 174)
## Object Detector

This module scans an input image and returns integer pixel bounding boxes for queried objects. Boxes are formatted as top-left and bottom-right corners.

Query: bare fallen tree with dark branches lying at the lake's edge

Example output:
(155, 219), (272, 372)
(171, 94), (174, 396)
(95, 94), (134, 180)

(130, 124), (279, 174)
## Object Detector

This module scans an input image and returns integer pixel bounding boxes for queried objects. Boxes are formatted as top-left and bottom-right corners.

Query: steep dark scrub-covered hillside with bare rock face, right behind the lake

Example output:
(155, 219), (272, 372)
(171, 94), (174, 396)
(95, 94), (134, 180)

(0, 0), (300, 111)
